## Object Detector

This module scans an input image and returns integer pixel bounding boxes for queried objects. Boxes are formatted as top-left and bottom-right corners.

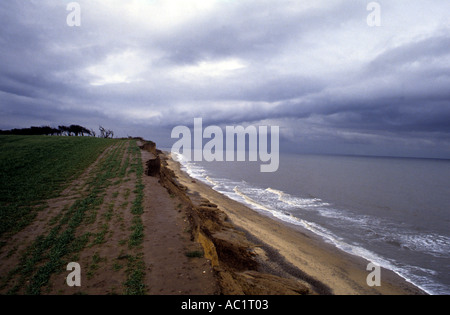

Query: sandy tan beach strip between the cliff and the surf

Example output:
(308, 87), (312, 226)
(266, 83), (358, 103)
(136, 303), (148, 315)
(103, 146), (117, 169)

(165, 153), (426, 295)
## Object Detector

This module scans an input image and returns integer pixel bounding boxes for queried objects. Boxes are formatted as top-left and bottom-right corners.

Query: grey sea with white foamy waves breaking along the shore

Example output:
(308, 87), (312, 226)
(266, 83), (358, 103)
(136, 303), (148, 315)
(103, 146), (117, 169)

(175, 154), (450, 294)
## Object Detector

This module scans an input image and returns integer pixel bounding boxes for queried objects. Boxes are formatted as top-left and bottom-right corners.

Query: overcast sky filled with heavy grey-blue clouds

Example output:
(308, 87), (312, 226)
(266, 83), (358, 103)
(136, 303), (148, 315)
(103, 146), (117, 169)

(0, 0), (450, 158)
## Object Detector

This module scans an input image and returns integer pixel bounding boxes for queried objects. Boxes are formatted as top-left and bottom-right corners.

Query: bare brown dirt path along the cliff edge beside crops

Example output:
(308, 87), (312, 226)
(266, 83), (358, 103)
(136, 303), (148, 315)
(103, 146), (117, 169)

(142, 151), (218, 295)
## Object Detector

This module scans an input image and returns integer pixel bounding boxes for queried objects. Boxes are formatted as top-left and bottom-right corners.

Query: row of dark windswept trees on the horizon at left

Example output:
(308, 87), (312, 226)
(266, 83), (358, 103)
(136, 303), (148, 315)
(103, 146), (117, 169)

(0, 125), (114, 138)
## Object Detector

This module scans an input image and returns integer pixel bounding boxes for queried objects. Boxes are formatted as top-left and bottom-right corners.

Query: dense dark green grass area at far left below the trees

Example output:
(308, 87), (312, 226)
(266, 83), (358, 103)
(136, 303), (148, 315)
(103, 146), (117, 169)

(0, 136), (117, 236)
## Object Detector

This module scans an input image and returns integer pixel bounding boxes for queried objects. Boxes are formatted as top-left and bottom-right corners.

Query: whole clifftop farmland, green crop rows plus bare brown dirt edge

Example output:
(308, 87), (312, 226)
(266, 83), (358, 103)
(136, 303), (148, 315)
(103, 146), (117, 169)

(0, 136), (216, 295)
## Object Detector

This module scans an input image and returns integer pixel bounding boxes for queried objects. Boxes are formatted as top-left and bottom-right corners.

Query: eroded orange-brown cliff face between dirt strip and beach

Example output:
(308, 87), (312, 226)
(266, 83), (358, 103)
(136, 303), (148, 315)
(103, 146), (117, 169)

(141, 143), (312, 295)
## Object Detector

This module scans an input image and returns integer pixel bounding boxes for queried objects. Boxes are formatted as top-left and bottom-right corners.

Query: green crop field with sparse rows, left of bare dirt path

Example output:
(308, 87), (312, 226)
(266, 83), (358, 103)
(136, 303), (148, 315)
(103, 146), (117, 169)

(0, 136), (146, 294)
